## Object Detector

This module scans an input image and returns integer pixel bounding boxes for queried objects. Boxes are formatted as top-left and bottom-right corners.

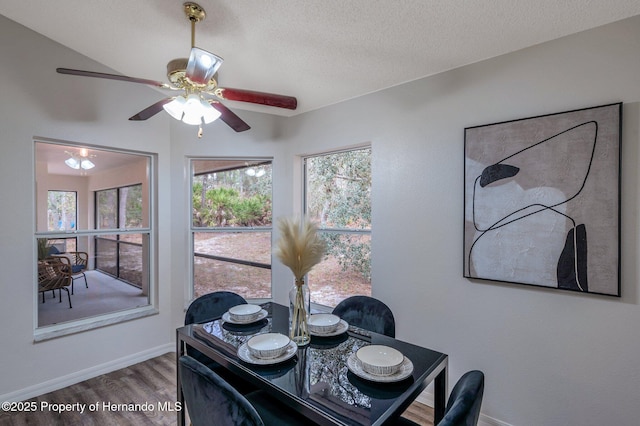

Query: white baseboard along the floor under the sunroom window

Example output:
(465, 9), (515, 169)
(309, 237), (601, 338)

(0, 343), (176, 402)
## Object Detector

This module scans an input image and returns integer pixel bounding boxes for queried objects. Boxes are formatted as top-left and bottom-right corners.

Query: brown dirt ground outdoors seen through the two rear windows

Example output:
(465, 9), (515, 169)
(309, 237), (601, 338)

(194, 232), (371, 307)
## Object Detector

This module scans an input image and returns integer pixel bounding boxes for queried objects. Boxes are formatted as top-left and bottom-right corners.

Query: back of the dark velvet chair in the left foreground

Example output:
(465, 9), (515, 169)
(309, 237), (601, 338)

(178, 355), (264, 426)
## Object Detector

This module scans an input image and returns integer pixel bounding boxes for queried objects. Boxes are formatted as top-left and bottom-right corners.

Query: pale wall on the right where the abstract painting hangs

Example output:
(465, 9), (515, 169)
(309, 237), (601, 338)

(278, 17), (640, 426)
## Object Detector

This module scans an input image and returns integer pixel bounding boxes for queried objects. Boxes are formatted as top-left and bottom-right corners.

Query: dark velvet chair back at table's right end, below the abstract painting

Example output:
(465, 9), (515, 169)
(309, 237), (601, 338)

(438, 370), (484, 426)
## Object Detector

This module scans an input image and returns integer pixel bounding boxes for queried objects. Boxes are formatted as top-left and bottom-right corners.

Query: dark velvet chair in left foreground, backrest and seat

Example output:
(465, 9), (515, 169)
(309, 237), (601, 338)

(178, 355), (312, 426)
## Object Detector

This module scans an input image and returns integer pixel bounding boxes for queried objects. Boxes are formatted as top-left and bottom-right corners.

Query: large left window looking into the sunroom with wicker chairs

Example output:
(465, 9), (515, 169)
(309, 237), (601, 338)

(34, 140), (157, 340)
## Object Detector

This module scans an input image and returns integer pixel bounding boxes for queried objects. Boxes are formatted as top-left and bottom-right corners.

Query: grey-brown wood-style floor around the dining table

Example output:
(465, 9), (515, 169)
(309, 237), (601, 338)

(0, 352), (433, 426)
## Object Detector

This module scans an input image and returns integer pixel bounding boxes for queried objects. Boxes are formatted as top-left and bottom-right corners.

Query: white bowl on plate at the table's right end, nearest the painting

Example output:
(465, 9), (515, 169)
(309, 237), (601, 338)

(347, 345), (413, 382)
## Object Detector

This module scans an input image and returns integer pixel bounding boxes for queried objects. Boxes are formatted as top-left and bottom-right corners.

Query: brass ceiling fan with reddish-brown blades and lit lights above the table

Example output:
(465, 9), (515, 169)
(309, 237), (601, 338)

(56, 2), (298, 137)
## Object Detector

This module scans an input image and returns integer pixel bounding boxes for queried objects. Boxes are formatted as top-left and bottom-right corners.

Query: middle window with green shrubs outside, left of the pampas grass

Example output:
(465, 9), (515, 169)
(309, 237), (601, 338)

(191, 159), (272, 299)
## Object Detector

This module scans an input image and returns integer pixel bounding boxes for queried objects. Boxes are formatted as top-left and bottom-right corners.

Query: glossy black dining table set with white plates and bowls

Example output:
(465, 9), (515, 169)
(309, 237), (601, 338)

(176, 302), (448, 426)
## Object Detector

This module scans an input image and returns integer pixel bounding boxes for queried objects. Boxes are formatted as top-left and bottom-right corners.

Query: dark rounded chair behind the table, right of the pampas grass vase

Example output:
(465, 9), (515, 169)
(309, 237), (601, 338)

(333, 296), (396, 337)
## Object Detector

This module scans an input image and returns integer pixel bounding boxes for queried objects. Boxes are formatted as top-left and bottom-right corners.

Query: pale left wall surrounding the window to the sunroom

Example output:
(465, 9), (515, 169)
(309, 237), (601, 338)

(0, 16), (175, 399)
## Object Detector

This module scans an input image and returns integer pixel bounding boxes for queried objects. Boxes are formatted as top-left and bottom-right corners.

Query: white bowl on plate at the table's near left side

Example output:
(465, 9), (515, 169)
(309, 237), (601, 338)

(238, 333), (298, 365)
